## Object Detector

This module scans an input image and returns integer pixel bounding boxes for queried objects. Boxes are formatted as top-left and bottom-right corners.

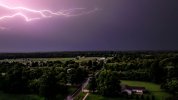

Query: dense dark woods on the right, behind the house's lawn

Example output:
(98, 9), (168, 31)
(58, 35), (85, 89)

(104, 52), (178, 94)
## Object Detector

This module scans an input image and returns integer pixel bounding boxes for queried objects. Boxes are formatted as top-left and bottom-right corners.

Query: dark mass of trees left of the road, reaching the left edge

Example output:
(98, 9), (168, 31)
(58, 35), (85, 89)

(0, 61), (88, 100)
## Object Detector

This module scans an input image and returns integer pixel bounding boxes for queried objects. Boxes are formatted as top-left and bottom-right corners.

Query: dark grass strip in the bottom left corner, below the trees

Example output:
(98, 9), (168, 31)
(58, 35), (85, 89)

(0, 92), (44, 100)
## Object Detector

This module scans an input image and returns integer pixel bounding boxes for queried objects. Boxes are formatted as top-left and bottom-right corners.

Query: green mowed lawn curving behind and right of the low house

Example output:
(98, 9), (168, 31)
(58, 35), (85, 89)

(121, 80), (171, 100)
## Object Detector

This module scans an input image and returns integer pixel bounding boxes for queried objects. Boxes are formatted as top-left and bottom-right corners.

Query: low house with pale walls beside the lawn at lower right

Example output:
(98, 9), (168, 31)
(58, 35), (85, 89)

(122, 85), (146, 95)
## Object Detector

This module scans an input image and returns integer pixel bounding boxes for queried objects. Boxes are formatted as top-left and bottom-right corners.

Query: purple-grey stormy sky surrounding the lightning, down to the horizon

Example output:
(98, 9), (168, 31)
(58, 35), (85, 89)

(0, 0), (178, 52)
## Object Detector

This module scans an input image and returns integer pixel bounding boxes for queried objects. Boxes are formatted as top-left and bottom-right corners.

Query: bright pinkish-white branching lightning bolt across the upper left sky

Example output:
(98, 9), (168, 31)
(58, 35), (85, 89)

(0, 4), (98, 22)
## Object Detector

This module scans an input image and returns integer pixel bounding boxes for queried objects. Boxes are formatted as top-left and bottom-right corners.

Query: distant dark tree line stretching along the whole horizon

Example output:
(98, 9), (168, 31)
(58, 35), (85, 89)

(0, 51), (177, 60)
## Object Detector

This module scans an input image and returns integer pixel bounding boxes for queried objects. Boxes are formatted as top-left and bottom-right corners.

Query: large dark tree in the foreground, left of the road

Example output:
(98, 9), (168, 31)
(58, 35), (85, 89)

(39, 68), (67, 100)
